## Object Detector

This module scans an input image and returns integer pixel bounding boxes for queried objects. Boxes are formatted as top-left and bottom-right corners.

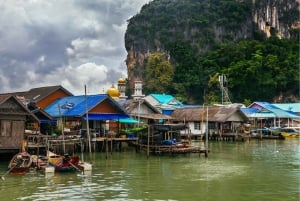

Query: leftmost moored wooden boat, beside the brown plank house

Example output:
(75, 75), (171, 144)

(8, 151), (32, 175)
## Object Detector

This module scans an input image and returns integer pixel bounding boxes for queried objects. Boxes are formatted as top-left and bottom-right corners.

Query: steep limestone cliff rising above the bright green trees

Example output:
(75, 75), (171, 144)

(125, 0), (300, 103)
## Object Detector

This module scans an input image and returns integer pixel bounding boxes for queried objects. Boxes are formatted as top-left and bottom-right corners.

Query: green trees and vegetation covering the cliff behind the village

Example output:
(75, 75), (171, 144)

(125, 0), (300, 104)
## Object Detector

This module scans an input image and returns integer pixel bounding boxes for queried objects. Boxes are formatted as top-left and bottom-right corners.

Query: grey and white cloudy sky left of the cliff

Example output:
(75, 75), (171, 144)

(0, 0), (149, 95)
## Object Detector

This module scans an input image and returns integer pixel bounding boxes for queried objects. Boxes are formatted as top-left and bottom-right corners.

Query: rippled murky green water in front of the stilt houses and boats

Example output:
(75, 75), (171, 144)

(0, 139), (300, 201)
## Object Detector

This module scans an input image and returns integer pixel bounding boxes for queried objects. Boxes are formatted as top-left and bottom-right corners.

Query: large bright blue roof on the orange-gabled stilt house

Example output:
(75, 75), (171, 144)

(45, 94), (108, 117)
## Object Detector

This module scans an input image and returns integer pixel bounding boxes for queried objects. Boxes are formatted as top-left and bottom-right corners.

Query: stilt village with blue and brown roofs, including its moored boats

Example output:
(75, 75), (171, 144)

(0, 78), (300, 179)
